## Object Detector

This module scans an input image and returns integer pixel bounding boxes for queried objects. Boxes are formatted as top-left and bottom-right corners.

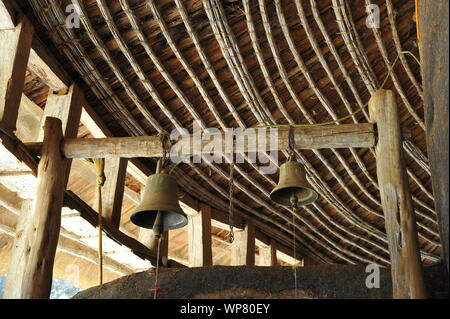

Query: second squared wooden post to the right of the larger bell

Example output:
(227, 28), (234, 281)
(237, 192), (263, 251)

(231, 222), (255, 266)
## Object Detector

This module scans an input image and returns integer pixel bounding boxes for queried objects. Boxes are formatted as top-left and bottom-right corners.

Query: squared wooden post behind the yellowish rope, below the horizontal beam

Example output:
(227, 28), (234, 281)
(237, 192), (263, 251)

(94, 158), (128, 228)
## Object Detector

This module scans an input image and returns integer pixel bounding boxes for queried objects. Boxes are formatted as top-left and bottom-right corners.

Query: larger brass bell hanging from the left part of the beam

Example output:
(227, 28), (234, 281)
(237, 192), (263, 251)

(131, 173), (188, 233)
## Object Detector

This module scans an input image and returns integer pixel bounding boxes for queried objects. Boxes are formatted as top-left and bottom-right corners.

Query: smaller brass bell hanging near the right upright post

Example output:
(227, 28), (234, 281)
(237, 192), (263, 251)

(270, 159), (317, 208)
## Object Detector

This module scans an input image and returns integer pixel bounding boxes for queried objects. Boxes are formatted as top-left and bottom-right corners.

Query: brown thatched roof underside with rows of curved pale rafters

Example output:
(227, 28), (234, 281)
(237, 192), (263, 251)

(8, 0), (441, 276)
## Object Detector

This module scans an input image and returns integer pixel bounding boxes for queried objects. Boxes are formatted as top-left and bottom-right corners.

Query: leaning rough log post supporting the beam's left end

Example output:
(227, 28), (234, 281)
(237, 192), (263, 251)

(4, 118), (66, 299)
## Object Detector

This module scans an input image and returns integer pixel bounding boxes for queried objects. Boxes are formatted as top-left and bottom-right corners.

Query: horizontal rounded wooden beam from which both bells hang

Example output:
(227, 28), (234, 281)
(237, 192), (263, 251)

(27, 123), (375, 158)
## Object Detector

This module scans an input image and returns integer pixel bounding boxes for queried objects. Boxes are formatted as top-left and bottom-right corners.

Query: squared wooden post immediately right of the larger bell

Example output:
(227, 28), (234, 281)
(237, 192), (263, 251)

(188, 203), (212, 267)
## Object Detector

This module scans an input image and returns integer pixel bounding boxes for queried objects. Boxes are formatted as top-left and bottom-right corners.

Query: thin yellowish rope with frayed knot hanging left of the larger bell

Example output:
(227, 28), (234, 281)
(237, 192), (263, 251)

(94, 158), (106, 285)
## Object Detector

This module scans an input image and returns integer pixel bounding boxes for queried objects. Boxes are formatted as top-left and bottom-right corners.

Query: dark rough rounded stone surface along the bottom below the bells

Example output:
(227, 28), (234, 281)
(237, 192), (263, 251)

(74, 263), (448, 299)
